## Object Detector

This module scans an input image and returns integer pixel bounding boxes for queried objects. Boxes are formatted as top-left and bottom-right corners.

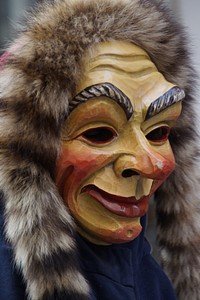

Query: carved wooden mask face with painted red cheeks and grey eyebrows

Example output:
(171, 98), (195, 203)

(56, 42), (184, 244)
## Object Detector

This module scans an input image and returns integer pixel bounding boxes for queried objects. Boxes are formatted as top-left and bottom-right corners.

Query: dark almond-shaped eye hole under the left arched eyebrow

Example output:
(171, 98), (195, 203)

(81, 127), (117, 144)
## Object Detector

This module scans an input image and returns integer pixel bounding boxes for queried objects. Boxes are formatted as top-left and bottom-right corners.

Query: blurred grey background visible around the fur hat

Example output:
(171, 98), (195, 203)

(0, 0), (200, 257)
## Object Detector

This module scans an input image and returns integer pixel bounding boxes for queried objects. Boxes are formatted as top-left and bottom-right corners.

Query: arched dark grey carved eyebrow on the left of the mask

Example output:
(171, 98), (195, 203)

(69, 82), (133, 120)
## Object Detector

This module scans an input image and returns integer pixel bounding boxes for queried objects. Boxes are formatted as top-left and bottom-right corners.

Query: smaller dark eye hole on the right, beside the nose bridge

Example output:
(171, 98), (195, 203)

(146, 126), (170, 143)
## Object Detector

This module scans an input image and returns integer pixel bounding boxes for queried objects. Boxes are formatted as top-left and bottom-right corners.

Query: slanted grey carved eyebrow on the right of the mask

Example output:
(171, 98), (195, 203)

(145, 86), (185, 121)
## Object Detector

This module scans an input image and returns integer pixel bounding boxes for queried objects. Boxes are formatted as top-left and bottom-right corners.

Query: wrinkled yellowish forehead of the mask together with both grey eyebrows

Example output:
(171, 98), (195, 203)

(69, 41), (185, 120)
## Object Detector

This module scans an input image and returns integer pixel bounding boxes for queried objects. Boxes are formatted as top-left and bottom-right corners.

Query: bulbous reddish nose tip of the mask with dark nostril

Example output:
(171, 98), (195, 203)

(114, 149), (174, 180)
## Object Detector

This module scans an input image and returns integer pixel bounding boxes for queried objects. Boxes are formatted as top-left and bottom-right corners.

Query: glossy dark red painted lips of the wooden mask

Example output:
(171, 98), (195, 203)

(81, 185), (150, 218)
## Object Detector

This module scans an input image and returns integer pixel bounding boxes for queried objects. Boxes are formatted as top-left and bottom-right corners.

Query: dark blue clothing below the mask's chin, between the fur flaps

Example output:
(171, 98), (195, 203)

(78, 217), (176, 300)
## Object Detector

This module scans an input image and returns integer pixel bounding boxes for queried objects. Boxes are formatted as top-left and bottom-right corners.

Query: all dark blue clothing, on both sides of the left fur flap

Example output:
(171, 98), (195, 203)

(0, 201), (176, 300)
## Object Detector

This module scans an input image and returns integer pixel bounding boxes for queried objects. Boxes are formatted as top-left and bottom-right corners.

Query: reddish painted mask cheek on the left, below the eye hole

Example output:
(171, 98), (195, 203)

(55, 141), (107, 204)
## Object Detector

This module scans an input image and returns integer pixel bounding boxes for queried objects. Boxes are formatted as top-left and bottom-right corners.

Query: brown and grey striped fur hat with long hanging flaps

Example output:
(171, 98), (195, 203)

(0, 0), (200, 300)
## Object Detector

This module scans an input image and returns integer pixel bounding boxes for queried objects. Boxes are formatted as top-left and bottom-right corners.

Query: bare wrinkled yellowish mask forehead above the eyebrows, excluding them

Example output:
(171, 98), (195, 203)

(76, 41), (174, 107)
